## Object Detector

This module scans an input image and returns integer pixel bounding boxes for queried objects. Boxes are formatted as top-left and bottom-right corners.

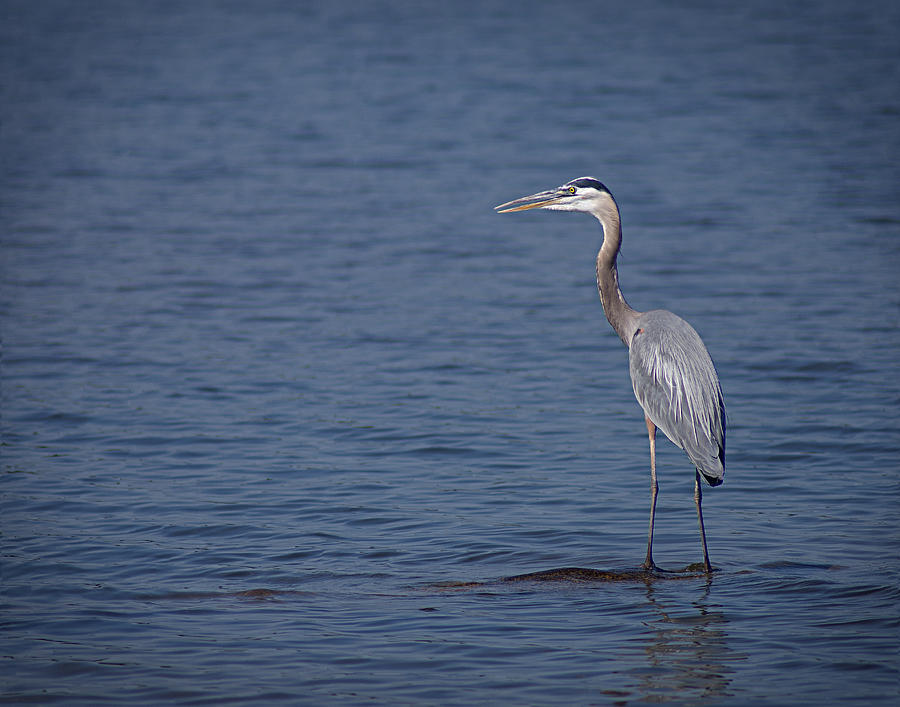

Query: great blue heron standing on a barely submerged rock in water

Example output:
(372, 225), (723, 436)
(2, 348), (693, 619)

(495, 177), (725, 572)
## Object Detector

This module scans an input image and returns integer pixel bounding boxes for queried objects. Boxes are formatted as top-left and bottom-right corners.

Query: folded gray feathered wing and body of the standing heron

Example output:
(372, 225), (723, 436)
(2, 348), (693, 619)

(628, 310), (725, 485)
